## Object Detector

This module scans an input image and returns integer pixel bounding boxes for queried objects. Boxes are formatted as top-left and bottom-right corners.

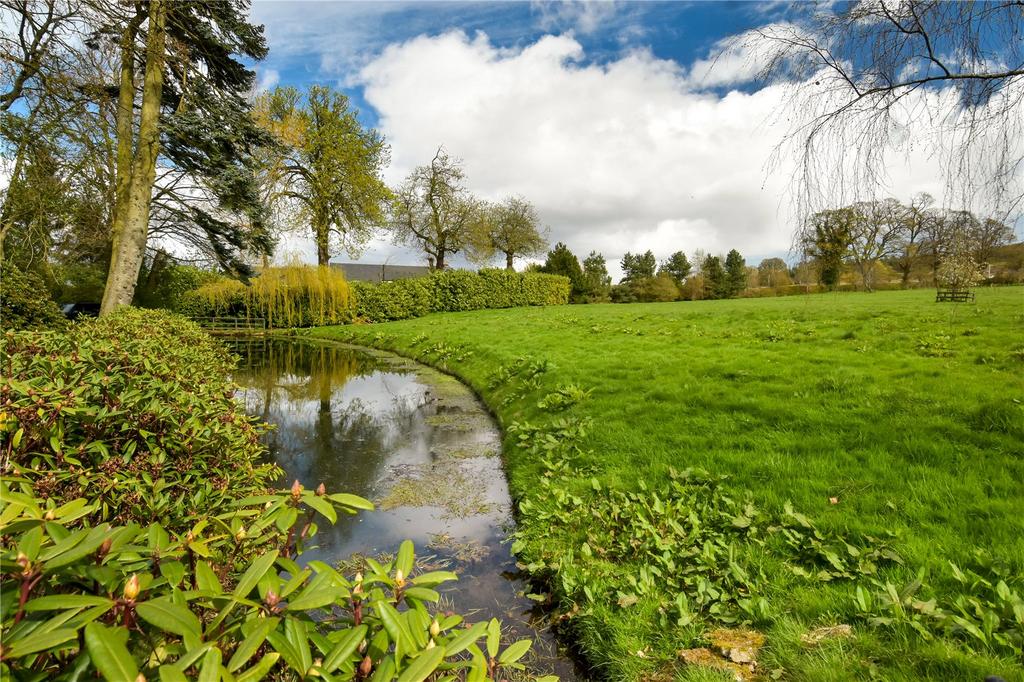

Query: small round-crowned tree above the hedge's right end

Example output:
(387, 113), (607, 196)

(467, 197), (548, 270)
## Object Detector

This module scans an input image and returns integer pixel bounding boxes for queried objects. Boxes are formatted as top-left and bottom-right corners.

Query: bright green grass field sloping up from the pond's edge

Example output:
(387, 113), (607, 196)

(303, 288), (1024, 680)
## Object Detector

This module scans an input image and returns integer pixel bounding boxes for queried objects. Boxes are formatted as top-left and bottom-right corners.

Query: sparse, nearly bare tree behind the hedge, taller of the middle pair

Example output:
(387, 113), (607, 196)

(391, 147), (481, 270)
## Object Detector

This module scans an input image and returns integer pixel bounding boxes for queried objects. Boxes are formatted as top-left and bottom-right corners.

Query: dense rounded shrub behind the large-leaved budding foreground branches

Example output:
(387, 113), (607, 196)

(0, 308), (278, 530)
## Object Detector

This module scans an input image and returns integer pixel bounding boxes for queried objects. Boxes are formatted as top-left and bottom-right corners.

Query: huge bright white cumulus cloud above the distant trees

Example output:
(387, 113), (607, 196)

(286, 31), (966, 273)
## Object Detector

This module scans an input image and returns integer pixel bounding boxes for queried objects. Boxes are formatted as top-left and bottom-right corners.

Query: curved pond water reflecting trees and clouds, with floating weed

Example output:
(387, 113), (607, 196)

(232, 339), (581, 680)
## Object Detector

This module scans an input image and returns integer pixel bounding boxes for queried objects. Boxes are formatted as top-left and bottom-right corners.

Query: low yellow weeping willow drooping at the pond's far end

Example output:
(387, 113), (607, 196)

(186, 264), (354, 328)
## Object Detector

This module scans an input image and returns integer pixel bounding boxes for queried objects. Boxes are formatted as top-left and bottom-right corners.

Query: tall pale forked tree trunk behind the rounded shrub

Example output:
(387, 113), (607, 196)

(99, 0), (167, 315)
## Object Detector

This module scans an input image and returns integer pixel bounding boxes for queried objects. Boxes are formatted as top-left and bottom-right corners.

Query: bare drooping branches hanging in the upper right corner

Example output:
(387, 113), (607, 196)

(727, 0), (1024, 215)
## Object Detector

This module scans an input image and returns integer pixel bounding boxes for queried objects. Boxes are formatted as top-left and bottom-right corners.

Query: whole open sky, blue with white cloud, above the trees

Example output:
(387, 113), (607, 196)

(245, 0), (1015, 279)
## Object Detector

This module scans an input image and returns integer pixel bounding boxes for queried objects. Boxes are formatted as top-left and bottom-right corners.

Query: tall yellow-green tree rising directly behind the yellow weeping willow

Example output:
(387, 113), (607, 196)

(254, 85), (391, 265)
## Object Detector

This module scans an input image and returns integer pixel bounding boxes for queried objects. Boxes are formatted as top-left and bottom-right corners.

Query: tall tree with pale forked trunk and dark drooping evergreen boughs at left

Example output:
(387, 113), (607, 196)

(97, 0), (271, 314)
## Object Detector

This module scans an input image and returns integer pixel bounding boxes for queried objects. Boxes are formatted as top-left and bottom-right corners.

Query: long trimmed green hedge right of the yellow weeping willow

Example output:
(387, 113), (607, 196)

(351, 269), (569, 322)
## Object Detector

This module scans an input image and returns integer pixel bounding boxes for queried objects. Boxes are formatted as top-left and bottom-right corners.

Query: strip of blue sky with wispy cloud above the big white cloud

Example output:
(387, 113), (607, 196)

(252, 0), (802, 126)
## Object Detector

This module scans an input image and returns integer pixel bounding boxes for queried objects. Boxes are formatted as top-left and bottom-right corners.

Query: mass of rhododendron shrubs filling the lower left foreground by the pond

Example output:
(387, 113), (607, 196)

(0, 309), (529, 682)
